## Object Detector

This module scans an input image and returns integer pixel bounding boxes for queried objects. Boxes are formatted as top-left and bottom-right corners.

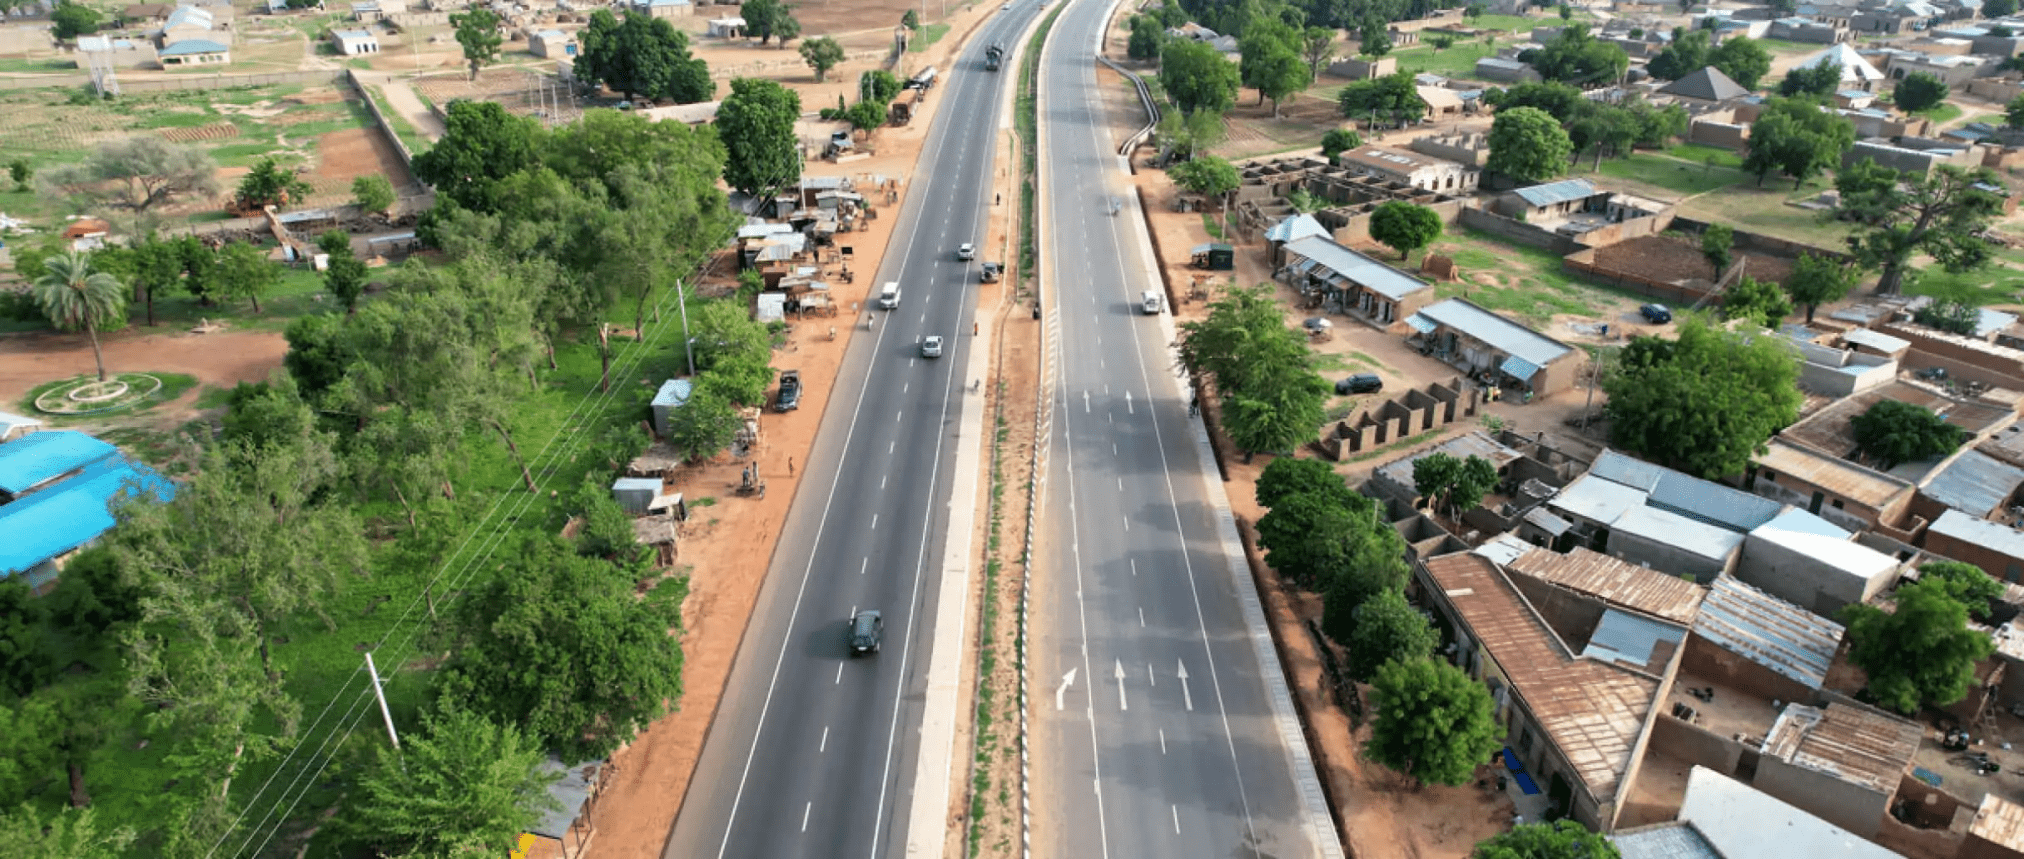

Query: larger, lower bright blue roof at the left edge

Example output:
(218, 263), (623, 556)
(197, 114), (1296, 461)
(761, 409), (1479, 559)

(0, 449), (176, 575)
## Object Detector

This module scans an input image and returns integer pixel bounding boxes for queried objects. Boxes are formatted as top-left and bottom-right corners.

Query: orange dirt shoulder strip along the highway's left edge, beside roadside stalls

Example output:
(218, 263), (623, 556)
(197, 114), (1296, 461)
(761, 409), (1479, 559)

(589, 8), (1020, 859)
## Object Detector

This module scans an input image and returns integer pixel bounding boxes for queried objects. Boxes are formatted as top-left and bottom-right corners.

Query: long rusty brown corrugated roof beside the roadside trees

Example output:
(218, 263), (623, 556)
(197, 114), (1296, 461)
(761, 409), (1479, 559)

(1427, 553), (1660, 804)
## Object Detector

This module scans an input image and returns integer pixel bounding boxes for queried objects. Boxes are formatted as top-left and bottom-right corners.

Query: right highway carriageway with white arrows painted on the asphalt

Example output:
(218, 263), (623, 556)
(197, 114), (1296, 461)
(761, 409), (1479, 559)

(1028, 0), (1342, 859)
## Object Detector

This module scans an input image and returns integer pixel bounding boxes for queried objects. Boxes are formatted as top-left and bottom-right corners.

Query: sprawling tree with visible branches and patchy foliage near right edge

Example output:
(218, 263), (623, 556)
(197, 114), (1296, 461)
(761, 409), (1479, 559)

(1834, 158), (2004, 296)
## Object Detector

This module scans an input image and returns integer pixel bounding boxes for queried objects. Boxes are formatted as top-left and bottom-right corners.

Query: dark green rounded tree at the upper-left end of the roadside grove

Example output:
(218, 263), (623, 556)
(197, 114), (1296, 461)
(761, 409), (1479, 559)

(415, 98), (542, 215)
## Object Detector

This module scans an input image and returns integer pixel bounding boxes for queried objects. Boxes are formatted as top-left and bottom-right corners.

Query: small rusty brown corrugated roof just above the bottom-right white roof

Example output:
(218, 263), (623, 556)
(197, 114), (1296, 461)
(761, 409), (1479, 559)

(1765, 703), (1923, 794)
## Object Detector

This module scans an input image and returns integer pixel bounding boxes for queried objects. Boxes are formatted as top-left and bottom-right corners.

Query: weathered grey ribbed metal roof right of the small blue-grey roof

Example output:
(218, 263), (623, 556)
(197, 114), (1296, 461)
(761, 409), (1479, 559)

(1694, 575), (1842, 689)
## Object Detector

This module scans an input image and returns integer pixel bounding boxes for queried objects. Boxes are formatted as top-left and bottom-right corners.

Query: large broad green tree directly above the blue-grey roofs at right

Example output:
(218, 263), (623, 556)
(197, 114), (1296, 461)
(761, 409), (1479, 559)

(1603, 320), (1803, 480)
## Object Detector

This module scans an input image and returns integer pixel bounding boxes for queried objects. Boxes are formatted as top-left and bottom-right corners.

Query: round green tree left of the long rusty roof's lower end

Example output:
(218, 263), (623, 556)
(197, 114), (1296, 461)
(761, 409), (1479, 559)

(1364, 658), (1502, 784)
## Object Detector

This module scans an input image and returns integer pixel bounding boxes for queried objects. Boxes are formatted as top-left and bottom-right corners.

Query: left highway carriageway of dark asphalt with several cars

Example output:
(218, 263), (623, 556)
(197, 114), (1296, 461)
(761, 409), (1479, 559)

(664, 0), (1040, 859)
